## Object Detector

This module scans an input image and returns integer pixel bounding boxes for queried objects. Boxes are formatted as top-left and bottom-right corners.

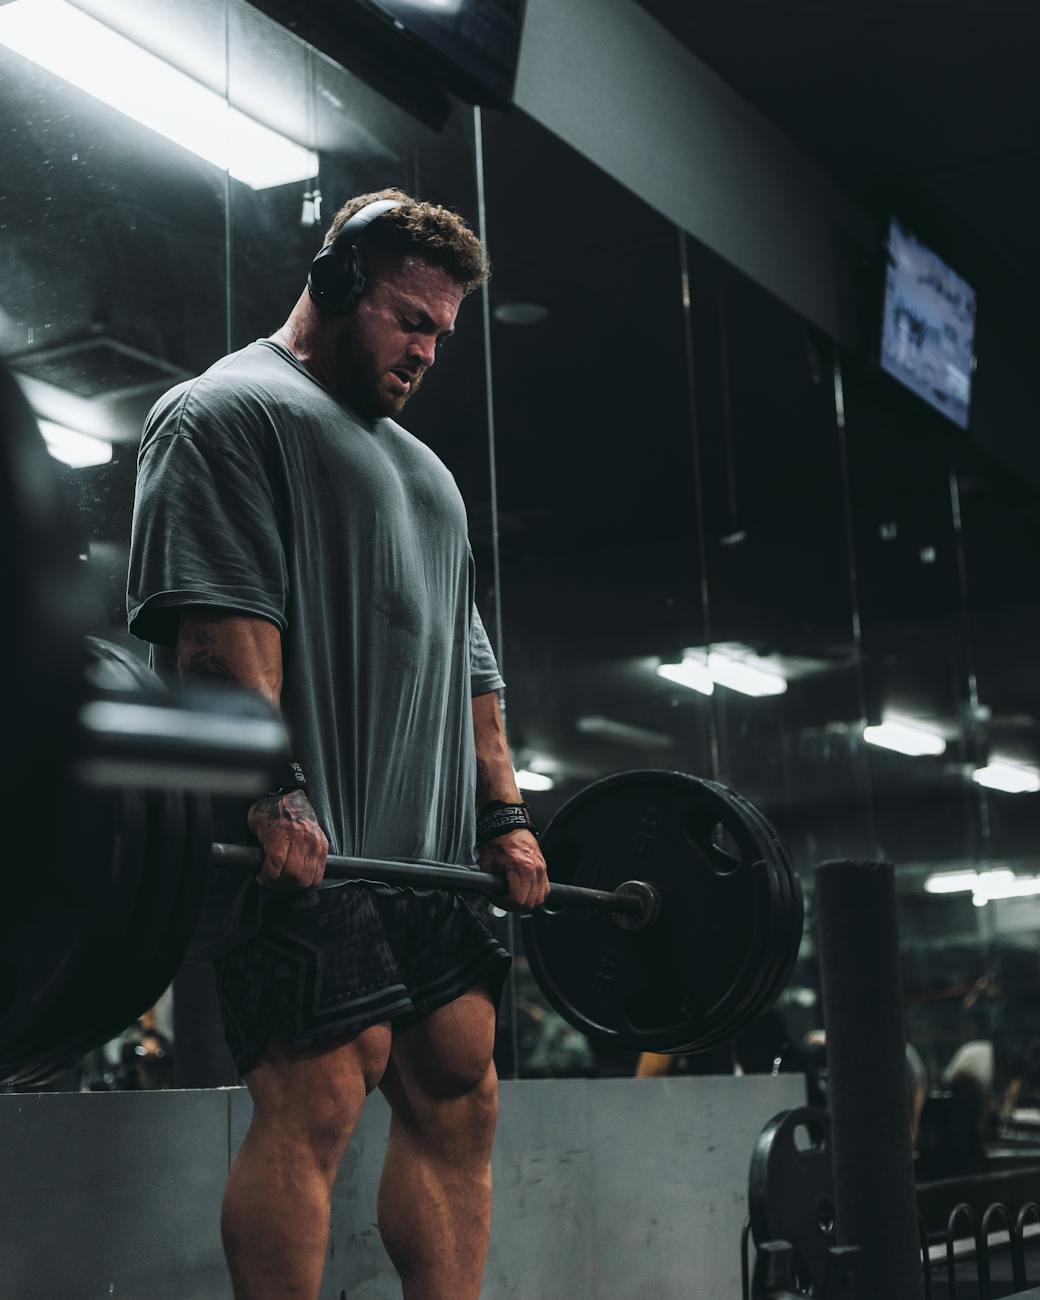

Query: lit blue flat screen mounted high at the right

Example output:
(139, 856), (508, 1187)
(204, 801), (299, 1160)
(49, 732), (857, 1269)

(881, 217), (975, 429)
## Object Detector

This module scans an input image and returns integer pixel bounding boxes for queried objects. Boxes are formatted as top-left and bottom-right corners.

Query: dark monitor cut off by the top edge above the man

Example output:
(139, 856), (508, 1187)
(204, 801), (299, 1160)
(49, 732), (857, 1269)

(363, 0), (525, 104)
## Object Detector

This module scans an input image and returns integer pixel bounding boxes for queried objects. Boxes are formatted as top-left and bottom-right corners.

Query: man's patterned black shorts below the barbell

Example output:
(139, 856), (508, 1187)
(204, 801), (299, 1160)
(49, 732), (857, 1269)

(213, 883), (511, 1075)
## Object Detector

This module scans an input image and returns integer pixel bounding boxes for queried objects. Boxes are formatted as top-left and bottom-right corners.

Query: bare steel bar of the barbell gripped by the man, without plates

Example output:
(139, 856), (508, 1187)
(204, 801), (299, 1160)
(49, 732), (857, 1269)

(213, 844), (657, 930)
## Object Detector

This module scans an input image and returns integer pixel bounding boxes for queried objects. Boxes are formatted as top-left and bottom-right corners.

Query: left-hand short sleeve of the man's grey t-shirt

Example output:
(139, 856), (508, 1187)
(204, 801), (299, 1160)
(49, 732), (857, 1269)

(126, 381), (287, 646)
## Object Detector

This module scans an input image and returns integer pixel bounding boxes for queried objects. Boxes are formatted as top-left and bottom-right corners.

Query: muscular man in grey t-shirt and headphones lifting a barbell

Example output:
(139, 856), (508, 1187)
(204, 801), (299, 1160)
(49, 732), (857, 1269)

(127, 190), (547, 1300)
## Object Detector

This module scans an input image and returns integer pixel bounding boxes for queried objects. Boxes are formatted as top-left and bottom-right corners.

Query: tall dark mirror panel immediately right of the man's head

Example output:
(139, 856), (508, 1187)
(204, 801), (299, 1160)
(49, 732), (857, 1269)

(484, 112), (711, 1075)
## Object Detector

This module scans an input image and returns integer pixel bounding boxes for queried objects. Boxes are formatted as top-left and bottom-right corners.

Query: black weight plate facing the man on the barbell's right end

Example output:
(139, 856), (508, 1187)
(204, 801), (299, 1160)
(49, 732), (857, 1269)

(524, 771), (779, 1052)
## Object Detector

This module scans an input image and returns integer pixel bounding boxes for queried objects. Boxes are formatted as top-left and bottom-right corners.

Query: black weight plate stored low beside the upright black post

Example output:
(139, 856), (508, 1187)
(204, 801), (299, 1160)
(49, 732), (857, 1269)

(748, 1106), (835, 1295)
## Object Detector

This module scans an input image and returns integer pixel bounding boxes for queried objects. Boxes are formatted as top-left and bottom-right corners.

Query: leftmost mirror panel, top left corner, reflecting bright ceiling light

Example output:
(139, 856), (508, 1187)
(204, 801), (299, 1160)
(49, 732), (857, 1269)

(0, 0), (225, 640)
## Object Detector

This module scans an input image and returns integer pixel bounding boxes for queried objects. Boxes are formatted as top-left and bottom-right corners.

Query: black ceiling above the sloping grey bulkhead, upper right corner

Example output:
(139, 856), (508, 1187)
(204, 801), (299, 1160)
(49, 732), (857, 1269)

(637, 0), (1040, 282)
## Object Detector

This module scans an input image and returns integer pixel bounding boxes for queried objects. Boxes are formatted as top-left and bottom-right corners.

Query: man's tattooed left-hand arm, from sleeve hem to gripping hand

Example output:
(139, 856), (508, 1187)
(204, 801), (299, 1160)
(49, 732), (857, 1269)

(177, 606), (329, 889)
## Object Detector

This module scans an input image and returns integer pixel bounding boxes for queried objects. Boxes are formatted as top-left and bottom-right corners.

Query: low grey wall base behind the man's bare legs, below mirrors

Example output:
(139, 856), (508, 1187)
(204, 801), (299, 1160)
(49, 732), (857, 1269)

(0, 1075), (803, 1300)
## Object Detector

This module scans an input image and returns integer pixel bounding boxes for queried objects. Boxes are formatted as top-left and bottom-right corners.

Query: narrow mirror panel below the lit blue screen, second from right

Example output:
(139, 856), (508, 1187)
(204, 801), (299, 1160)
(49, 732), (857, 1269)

(844, 363), (988, 1128)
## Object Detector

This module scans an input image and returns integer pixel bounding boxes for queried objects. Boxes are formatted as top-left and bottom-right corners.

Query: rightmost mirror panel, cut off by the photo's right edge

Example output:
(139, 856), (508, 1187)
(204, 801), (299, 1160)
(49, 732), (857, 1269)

(941, 446), (1040, 1141)
